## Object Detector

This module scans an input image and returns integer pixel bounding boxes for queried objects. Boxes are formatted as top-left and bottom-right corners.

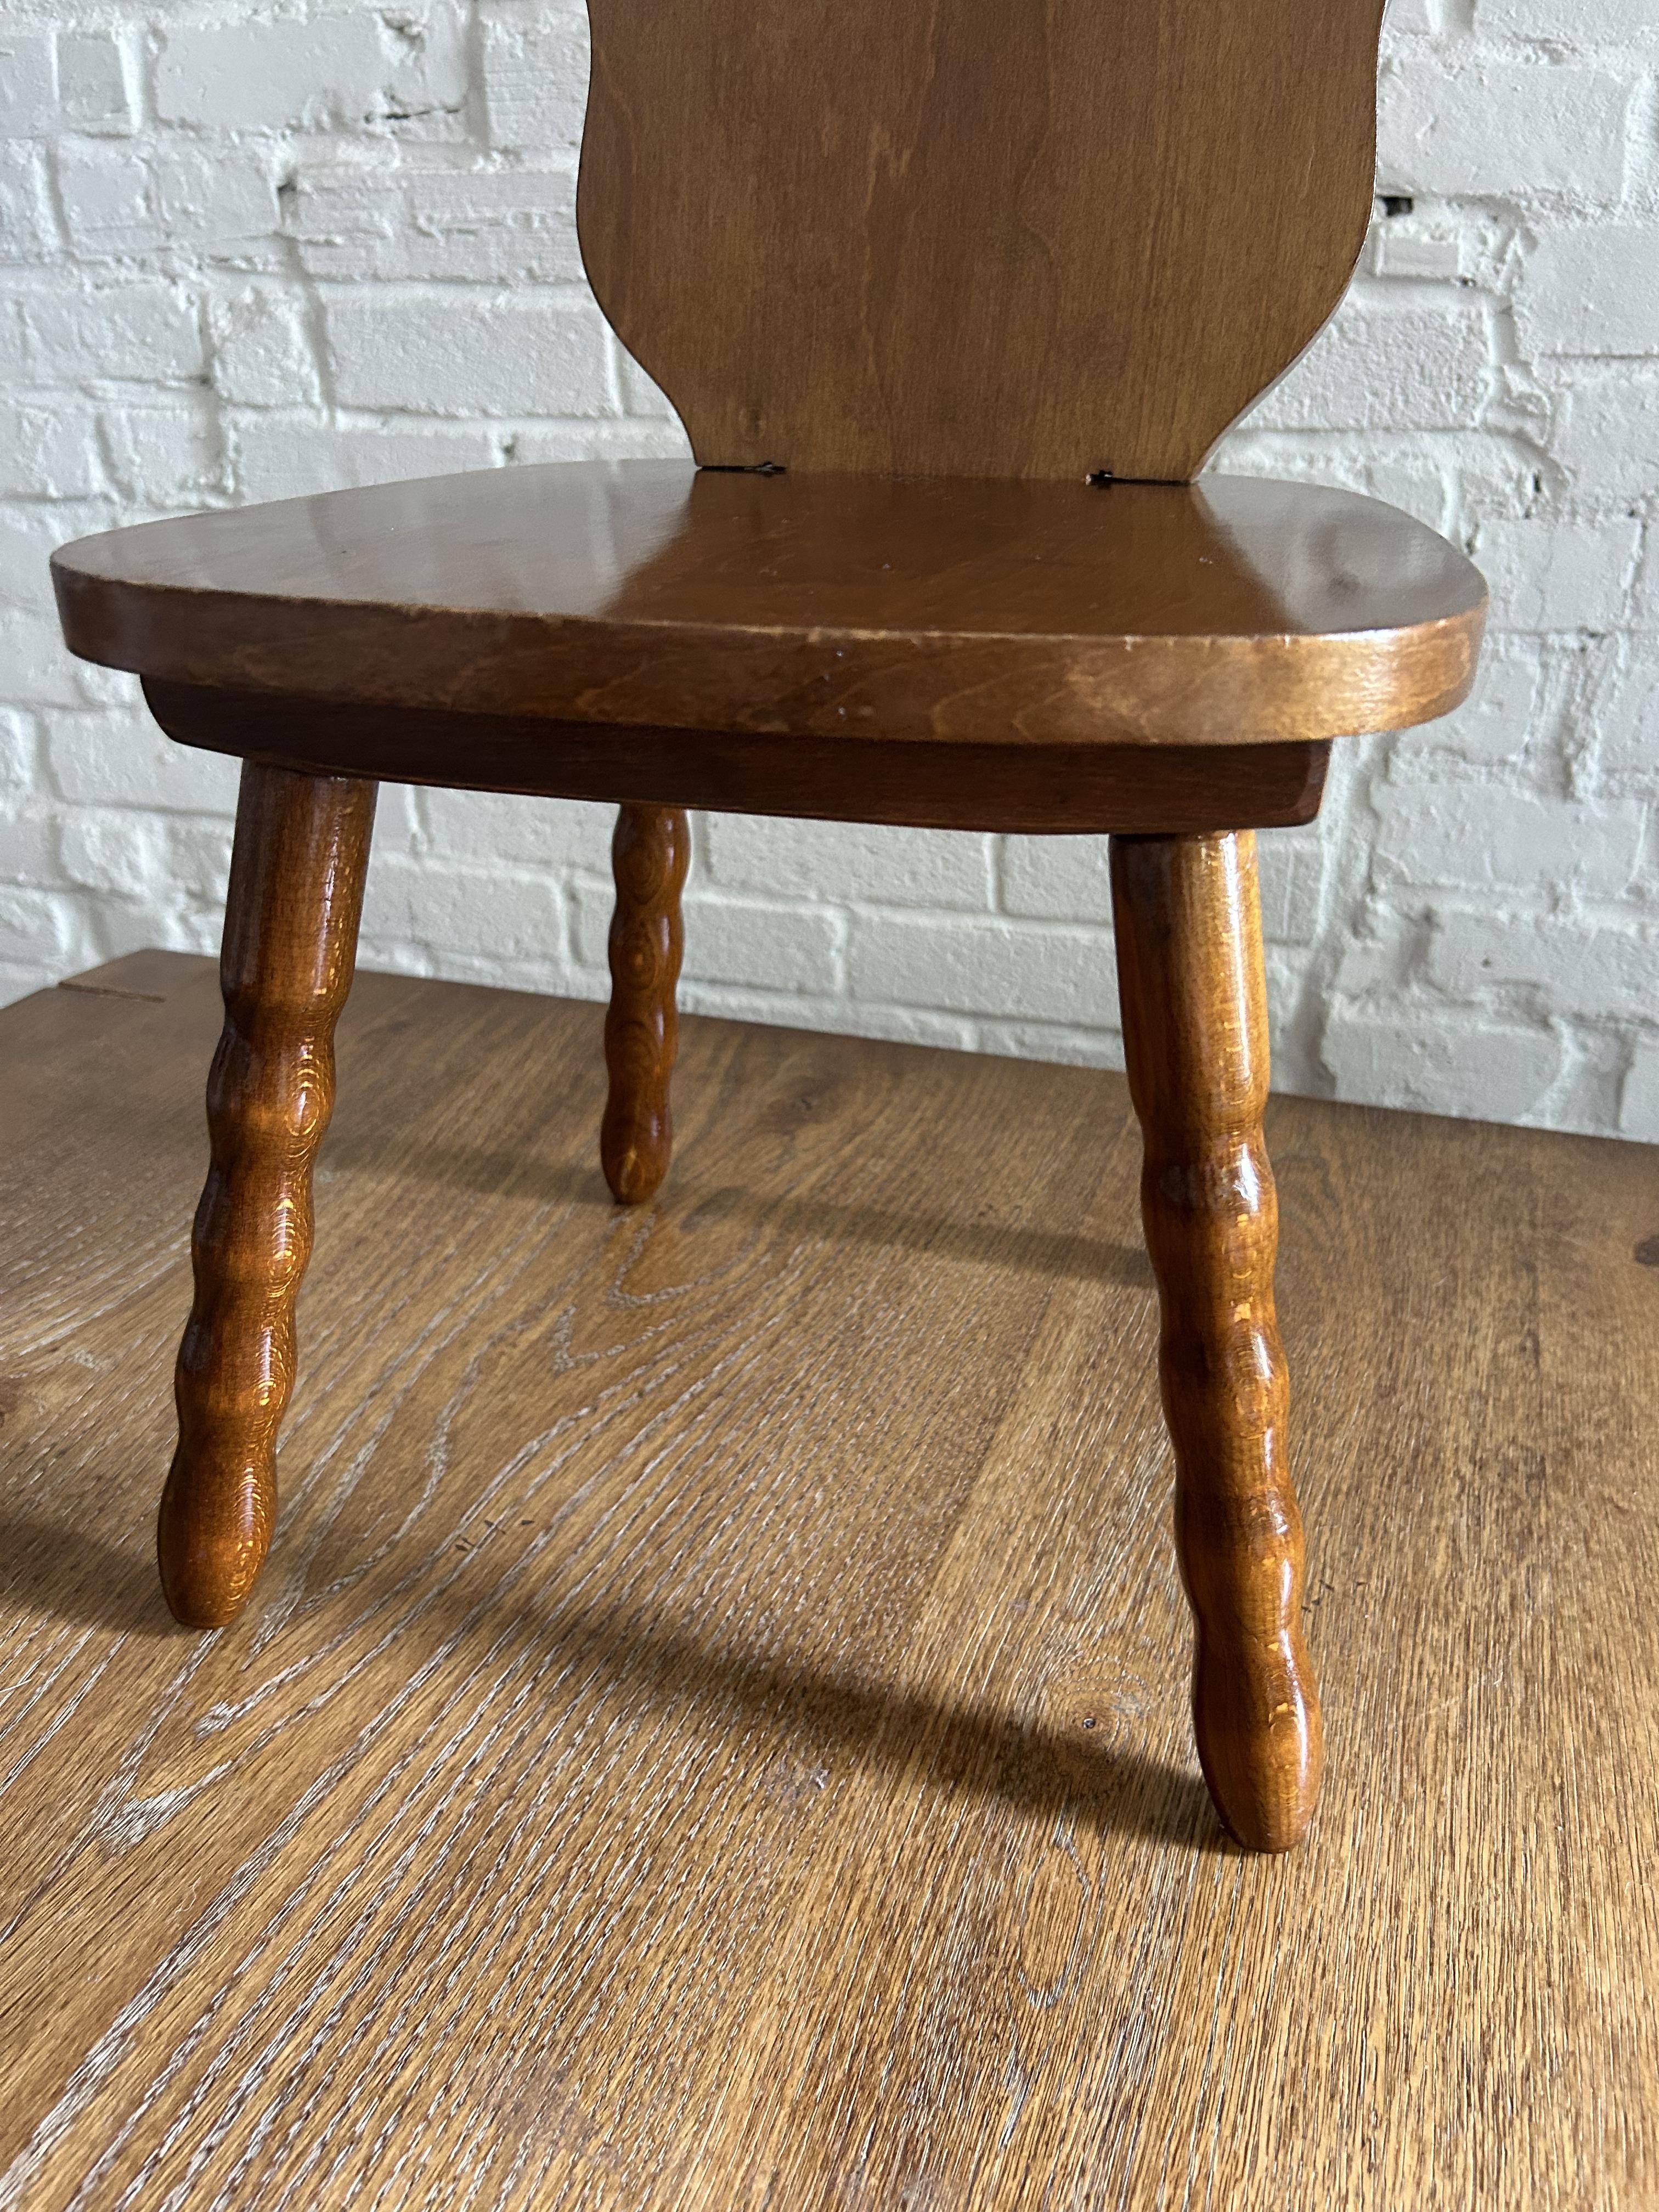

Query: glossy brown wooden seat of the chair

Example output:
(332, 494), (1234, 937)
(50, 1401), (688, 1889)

(53, 462), (1487, 747)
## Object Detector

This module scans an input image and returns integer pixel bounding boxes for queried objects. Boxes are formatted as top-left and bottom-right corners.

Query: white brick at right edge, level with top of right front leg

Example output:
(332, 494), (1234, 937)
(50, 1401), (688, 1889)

(1374, 783), (1646, 898)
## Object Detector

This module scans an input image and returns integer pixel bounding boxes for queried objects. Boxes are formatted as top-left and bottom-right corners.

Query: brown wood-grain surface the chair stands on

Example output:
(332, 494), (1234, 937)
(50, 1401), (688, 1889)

(0, 953), (1659, 2212)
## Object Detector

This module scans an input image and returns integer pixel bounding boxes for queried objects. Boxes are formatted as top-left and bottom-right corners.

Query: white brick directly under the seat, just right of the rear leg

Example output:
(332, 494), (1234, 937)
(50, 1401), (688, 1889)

(708, 814), (991, 911)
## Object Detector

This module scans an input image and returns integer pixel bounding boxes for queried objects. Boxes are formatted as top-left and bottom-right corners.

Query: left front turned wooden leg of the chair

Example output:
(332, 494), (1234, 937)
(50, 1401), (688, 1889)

(157, 761), (376, 1628)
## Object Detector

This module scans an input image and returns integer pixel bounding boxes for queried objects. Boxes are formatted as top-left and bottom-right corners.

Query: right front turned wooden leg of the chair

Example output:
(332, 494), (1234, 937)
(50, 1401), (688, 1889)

(1113, 832), (1323, 1852)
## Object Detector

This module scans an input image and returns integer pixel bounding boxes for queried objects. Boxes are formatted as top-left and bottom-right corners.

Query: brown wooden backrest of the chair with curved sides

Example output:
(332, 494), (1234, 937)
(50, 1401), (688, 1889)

(577, 0), (1383, 482)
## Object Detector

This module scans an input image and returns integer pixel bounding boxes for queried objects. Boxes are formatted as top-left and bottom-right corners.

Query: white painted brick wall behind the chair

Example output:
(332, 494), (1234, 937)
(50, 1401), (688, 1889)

(0, 0), (1659, 1139)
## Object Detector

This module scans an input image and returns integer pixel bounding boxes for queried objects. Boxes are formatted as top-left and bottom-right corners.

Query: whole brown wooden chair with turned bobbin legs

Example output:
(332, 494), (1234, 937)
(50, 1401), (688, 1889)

(45, 0), (1484, 1852)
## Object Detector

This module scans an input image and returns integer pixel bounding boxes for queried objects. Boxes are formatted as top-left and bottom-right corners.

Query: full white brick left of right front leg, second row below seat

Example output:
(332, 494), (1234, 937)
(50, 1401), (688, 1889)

(847, 913), (1119, 1029)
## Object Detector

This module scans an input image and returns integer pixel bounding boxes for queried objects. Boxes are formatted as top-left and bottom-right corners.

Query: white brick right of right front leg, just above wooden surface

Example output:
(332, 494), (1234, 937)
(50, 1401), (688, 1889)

(1321, 1007), (1562, 1121)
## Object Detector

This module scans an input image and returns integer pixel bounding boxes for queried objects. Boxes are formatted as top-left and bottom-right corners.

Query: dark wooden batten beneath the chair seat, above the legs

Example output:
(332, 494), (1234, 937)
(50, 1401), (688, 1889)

(144, 681), (1331, 832)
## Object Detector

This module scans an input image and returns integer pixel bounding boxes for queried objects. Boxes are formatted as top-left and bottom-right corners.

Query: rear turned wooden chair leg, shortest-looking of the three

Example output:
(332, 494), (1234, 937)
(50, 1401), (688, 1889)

(600, 805), (690, 1205)
